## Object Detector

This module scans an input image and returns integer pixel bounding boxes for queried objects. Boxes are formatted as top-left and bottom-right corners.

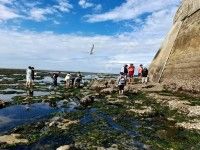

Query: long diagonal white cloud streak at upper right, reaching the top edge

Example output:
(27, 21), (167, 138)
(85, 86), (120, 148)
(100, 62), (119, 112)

(86, 0), (180, 22)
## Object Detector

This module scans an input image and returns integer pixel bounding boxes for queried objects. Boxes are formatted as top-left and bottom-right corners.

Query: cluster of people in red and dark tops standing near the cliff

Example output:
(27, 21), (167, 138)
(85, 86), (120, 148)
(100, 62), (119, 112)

(117, 64), (148, 94)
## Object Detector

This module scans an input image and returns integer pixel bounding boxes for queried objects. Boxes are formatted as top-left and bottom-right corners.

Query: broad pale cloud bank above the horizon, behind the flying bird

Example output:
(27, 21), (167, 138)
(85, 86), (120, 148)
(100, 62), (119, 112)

(0, 5), (176, 73)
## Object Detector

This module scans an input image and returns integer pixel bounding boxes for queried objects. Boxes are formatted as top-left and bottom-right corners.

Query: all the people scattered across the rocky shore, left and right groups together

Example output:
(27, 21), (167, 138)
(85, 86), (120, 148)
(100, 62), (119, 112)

(26, 64), (148, 94)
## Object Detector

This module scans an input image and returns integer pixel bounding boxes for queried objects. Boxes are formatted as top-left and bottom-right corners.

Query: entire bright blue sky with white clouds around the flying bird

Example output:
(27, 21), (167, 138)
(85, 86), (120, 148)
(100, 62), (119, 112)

(0, 0), (180, 73)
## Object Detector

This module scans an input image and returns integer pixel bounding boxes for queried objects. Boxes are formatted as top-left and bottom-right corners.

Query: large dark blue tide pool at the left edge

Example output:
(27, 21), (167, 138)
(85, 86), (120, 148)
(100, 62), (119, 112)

(0, 103), (59, 133)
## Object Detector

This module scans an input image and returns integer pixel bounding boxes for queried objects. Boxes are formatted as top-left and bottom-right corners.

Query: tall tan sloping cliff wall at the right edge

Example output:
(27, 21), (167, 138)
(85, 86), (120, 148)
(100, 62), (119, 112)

(150, 0), (200, 92)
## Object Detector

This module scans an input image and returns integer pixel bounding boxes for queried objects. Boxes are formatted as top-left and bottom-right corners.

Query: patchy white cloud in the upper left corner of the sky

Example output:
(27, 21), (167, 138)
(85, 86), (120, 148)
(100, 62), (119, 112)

(0, 0), (73, 21)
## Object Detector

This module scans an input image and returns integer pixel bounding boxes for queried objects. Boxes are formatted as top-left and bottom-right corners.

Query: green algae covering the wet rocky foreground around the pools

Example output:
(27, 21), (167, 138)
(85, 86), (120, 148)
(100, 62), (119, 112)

(0, 72), (200, 150)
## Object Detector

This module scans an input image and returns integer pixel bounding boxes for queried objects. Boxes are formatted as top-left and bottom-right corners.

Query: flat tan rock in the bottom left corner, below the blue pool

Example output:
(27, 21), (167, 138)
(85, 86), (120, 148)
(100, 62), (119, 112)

(0, 134), (28, 145)
